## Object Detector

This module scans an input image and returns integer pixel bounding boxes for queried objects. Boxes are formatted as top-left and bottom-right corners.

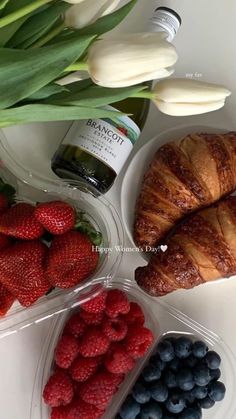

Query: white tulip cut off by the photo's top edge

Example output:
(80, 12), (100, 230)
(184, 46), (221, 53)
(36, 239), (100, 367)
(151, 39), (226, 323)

(65, 0), (120, 29)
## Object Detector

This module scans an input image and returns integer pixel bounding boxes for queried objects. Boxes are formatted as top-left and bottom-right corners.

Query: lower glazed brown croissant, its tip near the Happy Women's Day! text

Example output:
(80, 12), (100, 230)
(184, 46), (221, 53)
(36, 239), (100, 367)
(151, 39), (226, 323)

(135, 196), (236, 296)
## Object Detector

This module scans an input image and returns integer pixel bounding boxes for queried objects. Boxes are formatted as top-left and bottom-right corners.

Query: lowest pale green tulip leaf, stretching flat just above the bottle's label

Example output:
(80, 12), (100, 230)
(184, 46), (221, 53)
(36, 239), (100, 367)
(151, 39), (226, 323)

(0, 104), (126, 128)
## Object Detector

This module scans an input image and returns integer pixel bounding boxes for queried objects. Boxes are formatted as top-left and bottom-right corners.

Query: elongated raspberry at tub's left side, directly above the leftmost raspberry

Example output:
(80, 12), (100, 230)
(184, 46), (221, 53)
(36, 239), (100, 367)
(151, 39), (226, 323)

(55, 335), (79, 369)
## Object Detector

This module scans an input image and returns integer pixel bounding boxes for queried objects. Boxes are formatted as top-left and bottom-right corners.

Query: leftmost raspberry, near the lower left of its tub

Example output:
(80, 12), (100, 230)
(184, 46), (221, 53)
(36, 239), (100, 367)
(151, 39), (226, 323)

(43, 371), (74, 407)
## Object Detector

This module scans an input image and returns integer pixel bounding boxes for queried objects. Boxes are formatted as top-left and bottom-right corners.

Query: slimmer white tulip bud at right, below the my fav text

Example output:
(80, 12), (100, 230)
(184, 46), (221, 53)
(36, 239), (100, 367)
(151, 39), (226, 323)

(154, 79), (231, 116)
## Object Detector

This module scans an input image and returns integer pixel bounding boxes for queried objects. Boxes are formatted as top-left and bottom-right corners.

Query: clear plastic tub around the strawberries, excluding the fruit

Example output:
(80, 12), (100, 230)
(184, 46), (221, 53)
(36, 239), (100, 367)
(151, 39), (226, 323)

(0, 166), (124, 338)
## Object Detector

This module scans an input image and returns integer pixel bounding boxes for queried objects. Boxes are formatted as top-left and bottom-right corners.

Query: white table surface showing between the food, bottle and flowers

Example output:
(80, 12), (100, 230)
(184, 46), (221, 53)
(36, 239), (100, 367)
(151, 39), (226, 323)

(0, 0), (236, 419)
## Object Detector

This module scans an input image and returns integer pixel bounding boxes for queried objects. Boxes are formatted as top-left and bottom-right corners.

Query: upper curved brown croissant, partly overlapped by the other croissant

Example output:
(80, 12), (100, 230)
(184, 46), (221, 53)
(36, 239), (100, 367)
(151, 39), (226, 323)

(134, 132), (236, 247)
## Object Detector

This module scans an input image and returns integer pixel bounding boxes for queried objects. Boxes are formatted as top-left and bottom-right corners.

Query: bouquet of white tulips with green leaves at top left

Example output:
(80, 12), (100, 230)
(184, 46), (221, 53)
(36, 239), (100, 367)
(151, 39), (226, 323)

(0, 0), (230, 127)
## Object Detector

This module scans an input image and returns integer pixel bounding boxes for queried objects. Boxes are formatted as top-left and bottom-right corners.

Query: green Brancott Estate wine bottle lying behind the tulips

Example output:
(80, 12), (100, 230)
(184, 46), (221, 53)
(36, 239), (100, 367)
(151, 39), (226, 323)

(52, 7), (181, 194)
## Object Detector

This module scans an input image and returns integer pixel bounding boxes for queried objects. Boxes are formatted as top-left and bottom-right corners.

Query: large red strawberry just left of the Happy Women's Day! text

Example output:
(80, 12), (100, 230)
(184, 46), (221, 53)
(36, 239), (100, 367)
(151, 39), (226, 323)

(46, 231), (99, 288)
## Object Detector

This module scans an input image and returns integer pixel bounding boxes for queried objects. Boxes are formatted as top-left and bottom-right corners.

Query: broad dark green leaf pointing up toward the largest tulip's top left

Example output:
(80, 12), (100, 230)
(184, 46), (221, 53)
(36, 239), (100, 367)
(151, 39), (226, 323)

(0, 36), (94, 109)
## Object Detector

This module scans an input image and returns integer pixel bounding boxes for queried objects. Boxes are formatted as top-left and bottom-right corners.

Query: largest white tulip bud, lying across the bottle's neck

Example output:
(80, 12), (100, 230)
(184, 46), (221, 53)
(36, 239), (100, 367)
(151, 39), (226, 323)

(87, 33), (178, 88)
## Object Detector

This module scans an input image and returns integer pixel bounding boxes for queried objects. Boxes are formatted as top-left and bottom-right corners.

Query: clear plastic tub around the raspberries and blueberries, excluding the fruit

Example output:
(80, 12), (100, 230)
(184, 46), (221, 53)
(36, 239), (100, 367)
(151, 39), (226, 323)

(30, 279), (236, 419)
